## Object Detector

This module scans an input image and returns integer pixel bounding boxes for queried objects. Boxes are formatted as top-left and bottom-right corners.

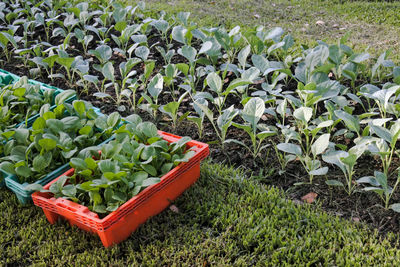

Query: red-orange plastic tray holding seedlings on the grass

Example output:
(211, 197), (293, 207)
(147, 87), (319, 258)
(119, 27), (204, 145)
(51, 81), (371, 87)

(32, 131), (209, 247)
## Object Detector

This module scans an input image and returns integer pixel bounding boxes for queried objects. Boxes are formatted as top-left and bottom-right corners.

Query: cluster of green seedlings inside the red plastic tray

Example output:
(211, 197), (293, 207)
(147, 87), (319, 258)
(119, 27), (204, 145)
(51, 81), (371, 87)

(36, 120), (194, 214)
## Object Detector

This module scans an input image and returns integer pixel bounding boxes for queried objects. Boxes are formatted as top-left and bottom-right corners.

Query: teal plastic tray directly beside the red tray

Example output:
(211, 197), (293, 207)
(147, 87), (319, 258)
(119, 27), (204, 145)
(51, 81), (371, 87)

(4, 136), (114, 205)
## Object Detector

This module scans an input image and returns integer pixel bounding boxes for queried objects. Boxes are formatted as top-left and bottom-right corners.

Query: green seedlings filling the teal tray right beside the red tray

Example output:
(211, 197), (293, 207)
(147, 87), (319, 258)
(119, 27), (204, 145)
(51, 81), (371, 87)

(0, 100), (119, 183)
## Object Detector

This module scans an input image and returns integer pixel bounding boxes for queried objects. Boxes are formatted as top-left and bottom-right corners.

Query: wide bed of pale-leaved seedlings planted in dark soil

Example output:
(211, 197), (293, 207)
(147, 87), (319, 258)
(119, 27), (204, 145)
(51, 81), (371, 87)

(0, 1), (400, 218)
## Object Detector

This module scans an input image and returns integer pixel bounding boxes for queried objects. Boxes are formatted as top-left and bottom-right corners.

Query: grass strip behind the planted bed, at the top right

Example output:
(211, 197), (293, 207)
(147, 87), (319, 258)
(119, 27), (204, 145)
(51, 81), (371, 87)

(141, 0), (400, 62)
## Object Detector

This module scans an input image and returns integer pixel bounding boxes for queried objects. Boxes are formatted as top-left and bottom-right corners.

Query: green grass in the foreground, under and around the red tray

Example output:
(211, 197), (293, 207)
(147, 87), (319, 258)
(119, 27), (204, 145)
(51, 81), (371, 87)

(0, 163), (400, 266)
